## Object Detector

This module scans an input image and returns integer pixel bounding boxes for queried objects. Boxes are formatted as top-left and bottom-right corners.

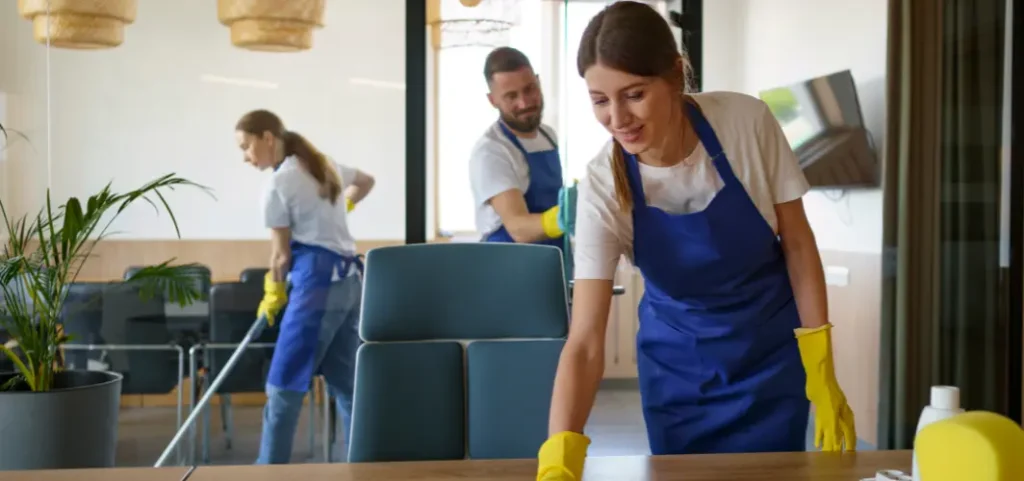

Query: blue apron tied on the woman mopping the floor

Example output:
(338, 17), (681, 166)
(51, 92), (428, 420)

(267, 243), (362, 392)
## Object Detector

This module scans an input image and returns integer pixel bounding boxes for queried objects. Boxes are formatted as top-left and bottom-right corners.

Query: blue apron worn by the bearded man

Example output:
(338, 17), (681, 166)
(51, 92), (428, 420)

(483, 122), (564, 248)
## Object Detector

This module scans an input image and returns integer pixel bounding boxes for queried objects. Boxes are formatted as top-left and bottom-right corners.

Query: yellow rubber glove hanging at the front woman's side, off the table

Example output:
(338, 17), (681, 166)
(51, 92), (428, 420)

(795, 324), (857, 451)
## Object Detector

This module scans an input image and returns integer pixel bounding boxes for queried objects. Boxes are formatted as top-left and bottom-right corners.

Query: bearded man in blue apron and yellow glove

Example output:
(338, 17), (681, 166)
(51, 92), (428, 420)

(470, 47), (575, 259)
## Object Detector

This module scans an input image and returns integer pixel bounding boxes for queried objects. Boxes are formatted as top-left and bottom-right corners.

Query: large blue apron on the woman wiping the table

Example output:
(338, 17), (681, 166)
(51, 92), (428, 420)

(626, 103), (810, 454)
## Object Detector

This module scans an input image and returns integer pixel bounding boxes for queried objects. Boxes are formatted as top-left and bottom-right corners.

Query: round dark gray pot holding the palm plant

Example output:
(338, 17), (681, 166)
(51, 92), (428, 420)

(0, 370), (122, 468)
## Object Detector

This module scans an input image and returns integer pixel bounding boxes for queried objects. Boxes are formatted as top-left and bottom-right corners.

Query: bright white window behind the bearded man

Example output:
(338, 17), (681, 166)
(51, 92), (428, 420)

(435, 0), (668, 237)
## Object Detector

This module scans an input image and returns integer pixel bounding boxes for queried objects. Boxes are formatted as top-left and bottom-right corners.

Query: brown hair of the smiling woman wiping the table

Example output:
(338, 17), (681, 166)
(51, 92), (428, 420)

(577, 1), (693, 212)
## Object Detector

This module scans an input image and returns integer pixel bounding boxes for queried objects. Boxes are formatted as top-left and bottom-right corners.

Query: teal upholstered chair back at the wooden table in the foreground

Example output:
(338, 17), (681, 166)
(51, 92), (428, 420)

(348, 244), (568, 463)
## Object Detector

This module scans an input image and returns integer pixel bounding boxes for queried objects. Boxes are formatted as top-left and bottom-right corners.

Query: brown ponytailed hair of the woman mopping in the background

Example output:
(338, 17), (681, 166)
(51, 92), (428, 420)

(234, 110), (341, 205)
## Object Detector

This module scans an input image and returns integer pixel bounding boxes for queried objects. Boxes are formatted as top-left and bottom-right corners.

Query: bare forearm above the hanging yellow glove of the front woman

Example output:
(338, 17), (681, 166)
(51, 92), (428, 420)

(783, 236), (828, 327)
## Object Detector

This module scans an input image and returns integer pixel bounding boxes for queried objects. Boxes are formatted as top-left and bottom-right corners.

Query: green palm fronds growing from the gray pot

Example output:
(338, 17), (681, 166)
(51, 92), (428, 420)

(0, 174), (212, 391)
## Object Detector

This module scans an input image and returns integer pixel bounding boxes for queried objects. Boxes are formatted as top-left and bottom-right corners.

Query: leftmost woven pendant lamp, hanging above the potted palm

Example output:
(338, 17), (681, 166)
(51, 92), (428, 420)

(17, 0), (136, 49)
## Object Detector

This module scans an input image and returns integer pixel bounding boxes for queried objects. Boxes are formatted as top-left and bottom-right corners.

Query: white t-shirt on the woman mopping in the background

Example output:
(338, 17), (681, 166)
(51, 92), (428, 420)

(263, 157), (356, 256)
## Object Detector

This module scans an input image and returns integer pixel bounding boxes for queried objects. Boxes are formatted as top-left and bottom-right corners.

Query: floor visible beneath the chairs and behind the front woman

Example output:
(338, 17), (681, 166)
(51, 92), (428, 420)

(117, 389), (872, 466)
